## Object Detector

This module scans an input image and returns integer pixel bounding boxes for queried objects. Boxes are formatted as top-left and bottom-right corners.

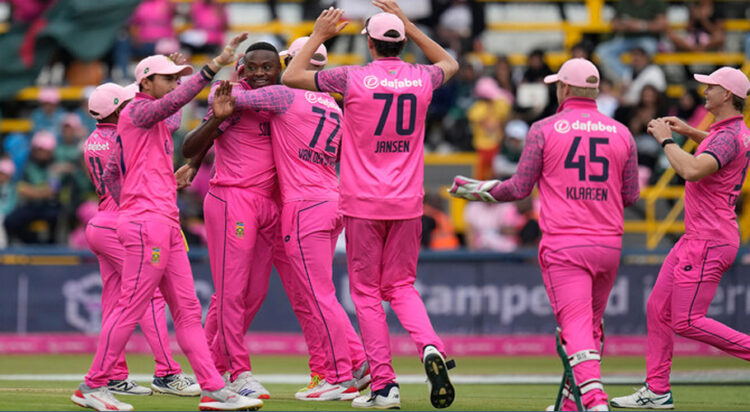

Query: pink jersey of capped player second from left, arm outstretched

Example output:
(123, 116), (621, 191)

(117, 72), (209, 227)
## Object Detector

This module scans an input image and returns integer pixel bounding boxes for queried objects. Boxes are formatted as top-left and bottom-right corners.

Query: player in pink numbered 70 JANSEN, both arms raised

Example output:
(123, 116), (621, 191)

(282, 0), (458, 408)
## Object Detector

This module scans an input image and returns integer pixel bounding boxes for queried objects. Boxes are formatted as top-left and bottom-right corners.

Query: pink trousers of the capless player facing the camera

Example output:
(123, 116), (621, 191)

(204, 187), (325, 380)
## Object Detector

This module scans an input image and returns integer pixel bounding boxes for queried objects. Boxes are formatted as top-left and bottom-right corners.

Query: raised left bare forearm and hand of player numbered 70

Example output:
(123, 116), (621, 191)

(281, 7), (348, 91)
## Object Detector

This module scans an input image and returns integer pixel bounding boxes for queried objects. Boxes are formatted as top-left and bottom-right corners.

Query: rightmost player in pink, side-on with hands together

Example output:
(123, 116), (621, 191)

(612, 67), (750, 409)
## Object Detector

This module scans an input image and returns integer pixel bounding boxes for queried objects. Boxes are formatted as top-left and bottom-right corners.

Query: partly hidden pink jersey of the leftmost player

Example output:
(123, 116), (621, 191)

(83, 123), (119, 212)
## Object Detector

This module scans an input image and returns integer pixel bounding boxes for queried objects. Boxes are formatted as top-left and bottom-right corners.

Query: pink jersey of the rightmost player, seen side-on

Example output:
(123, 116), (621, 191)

(685, 116), (750, 246)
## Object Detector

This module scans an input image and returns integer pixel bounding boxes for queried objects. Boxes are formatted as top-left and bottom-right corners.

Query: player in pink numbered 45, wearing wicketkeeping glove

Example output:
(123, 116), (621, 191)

(450, 59), (639, 410)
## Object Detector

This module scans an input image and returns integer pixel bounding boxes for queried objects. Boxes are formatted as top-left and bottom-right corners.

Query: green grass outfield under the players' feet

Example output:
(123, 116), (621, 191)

(0, 355), (750, 411)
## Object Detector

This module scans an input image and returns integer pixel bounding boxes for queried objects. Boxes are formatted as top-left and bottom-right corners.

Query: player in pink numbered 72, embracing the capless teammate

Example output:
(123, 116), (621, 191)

(212, 37), (374, 400)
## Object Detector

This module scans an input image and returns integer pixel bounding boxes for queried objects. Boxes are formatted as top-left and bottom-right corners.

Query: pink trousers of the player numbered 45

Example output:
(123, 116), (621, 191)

(539, 235), (622, 410)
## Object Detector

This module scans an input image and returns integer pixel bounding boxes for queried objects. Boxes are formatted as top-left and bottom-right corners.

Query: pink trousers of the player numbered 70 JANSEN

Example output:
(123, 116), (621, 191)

(344, 216), (445, 390)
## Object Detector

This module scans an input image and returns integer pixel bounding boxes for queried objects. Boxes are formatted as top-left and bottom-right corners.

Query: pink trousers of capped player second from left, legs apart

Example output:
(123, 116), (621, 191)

(86, 217), (224, 391)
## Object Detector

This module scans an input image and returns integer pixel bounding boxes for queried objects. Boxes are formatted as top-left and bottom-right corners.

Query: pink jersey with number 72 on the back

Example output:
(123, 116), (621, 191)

(235, 85), (343, 203)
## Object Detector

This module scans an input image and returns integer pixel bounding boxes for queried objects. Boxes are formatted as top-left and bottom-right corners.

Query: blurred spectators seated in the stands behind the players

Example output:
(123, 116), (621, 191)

(0, 0), (750, 251)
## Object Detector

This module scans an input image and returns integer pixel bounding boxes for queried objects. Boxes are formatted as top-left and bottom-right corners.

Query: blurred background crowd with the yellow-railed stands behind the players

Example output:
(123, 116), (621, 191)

(0, 0), (750, 252)
